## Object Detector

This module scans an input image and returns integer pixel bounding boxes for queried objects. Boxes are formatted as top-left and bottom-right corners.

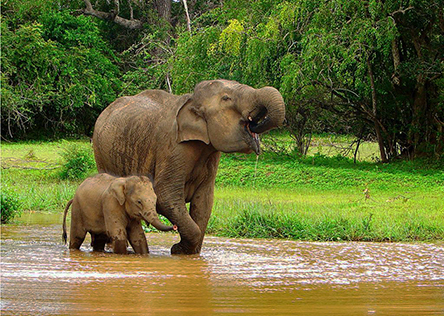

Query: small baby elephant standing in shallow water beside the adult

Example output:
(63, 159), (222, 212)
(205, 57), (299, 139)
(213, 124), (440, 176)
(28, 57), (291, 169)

(63, 173), (177, 254)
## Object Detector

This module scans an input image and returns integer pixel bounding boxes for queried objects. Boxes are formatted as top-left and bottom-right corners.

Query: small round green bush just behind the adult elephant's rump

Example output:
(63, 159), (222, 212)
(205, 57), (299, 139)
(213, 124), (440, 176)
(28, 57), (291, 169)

(60, 145), (95, 180)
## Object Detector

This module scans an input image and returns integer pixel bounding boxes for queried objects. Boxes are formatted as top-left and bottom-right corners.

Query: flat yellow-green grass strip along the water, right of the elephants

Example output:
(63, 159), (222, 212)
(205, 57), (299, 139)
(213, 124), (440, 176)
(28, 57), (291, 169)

(209, 188), (444, 241)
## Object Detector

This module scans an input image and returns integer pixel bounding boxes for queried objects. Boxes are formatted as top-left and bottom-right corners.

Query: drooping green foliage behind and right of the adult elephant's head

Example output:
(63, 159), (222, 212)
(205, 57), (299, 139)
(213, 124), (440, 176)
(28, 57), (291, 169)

(170, 0), (444, 158)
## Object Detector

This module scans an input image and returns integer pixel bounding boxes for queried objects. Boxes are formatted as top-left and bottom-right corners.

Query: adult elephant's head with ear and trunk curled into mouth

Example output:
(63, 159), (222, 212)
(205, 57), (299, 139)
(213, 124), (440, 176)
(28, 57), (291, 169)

(176, 80), (285, 154)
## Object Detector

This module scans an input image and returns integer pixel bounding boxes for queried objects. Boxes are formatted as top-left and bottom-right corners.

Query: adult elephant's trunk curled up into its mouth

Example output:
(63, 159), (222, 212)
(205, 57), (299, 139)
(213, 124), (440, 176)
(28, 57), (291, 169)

(249, 87), (285, 134)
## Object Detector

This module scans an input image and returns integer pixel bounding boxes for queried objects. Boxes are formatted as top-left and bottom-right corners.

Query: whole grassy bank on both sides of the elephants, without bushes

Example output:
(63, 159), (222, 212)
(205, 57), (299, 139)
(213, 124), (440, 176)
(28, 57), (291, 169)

(2, 141), (444, 241)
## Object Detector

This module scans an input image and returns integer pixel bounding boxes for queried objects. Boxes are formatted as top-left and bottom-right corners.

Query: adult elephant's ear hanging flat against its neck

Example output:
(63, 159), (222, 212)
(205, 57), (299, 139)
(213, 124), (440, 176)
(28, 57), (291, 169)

(176, 95), (210, 145)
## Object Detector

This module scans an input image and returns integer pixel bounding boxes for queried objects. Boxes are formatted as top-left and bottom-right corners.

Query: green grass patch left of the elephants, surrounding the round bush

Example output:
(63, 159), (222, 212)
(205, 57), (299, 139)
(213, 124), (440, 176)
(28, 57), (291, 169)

(1, 140), (92, 212)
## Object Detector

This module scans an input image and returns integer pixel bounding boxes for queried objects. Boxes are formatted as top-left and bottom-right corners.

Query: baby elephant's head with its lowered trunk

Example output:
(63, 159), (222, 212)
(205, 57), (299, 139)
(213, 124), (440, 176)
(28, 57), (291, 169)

(108, 176), (177, 231)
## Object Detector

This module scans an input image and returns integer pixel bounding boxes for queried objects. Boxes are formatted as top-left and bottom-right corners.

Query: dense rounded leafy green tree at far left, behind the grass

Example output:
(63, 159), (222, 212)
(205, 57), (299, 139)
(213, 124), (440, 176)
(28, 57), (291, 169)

(1, 6), (120, 138)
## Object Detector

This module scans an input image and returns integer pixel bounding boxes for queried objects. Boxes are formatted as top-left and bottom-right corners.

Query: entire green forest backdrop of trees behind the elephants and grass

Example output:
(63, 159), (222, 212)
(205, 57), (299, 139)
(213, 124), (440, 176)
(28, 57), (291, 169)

(1, 0), (444, 161)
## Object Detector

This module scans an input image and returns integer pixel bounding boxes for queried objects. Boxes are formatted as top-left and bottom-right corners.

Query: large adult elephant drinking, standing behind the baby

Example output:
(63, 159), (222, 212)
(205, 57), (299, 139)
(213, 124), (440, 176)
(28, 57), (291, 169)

(93, 80), (285, 254)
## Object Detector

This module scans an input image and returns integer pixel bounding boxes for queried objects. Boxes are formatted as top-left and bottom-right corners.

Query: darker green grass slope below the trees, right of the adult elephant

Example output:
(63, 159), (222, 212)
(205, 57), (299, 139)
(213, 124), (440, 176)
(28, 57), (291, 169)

(216, 153), (444, 193)
